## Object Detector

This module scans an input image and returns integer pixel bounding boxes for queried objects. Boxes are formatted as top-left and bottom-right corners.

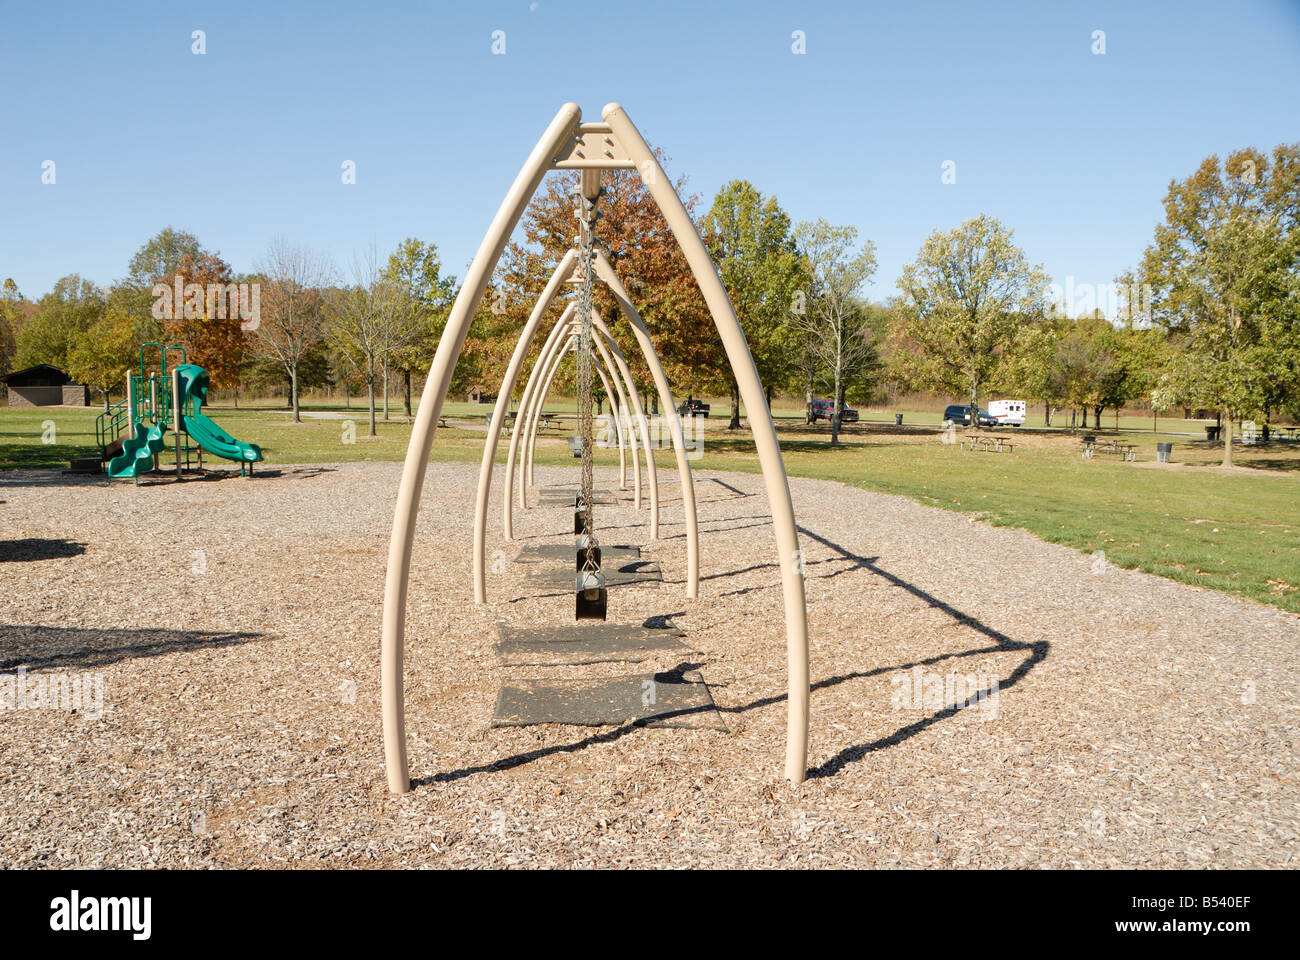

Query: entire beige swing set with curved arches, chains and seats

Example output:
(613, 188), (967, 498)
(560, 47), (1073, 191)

(381, 103), (809, 793)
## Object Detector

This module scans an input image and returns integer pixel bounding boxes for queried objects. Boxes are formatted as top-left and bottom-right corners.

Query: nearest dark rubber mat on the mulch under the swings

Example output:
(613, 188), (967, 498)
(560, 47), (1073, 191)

(491, 671), (727, 731)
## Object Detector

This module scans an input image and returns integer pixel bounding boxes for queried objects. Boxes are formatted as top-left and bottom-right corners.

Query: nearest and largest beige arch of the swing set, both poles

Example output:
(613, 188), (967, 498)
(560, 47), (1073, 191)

(381, 103), (809, 793)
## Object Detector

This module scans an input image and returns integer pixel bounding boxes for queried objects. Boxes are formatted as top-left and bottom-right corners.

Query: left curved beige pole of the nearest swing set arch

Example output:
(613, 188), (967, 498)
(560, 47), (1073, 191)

(380, 103), (582, 793)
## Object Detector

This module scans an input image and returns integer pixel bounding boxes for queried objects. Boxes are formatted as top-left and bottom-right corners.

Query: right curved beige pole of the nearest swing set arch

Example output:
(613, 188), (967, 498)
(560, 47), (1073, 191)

(601, 103), (809, 783)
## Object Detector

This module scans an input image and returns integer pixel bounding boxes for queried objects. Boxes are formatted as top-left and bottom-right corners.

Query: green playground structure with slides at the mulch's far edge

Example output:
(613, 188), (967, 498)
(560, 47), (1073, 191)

(95, 343), (263, 483)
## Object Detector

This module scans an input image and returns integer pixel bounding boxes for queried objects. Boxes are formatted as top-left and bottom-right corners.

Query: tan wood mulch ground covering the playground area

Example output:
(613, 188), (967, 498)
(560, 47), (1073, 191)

(0, 463), (1300, 868)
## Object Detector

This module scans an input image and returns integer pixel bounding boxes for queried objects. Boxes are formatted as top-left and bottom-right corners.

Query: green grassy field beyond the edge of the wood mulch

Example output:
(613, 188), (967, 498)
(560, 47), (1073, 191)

(0, 402), (1300, 613)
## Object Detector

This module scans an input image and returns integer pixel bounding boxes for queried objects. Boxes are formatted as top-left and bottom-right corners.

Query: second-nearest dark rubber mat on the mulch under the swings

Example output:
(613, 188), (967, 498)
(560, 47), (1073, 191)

(493, 622), (694, 666)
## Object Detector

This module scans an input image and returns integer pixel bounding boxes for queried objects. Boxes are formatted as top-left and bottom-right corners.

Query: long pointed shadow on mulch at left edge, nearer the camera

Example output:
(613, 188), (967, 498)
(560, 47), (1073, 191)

(0, 624), (268, 670)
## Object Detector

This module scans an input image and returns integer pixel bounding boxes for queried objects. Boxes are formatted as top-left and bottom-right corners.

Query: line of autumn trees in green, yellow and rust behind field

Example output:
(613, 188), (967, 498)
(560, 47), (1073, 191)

(0, 144), (1300, 462)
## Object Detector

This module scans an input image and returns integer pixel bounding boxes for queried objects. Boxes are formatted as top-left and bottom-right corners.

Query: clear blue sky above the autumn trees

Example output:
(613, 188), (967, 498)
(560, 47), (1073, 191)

(0, 0), (1300, 306)
